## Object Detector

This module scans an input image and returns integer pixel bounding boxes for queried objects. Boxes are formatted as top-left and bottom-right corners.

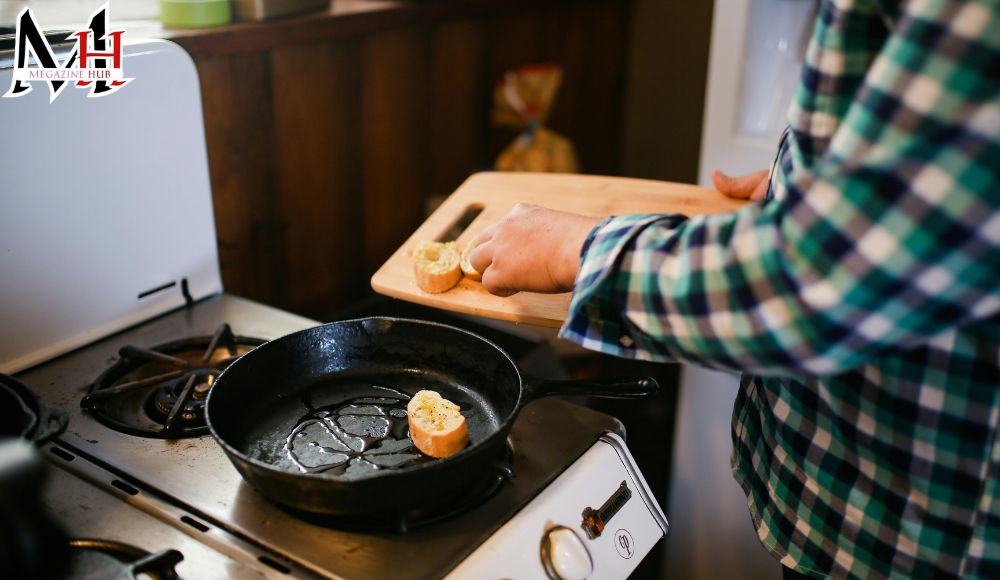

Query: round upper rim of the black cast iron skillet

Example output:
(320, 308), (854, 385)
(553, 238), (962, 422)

(205, 316), (525, 484)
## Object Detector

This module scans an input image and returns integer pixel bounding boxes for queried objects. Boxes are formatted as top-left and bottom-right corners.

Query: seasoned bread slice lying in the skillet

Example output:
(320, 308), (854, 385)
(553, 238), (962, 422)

(406, 390), (469, 458)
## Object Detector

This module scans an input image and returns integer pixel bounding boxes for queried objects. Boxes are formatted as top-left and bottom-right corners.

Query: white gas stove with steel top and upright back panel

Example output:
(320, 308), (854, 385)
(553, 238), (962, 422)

(0, 41), (667, 578)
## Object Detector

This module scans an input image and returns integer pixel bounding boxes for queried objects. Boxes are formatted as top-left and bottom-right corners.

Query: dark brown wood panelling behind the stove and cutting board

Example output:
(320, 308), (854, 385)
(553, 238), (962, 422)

(179, 0), (630, 318)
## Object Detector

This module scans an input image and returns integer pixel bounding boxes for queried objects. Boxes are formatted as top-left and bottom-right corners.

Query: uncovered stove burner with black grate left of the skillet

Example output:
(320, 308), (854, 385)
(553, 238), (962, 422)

(80, 324), (264, 439)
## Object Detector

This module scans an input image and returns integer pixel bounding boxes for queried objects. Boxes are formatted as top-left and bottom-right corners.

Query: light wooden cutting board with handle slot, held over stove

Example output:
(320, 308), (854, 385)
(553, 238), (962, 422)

(372, 172), (744, 327)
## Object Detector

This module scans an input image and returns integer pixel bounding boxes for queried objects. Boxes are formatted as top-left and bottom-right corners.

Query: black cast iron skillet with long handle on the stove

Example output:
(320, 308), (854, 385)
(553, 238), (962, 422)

(205, 318), (657, 516)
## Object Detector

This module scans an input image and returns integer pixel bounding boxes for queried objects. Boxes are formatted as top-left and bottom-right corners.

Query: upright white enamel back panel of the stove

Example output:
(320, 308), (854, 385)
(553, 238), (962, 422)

(0, 42), (222, 373)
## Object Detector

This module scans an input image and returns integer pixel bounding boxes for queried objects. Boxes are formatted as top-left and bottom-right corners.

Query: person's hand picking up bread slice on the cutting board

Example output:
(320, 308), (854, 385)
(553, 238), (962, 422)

(470, 203), (599, 296)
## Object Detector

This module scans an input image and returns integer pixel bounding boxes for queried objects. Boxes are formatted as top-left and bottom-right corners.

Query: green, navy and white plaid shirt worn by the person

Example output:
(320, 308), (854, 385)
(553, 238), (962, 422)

(561, 0), (1000, 578)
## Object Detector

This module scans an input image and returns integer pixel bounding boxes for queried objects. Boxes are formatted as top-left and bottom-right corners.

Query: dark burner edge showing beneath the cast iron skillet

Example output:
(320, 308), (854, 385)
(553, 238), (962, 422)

(279, 440), (514, 534)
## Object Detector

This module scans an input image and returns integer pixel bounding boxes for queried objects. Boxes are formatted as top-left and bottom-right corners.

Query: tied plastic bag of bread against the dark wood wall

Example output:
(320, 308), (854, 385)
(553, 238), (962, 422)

(493, 65), (580, 173)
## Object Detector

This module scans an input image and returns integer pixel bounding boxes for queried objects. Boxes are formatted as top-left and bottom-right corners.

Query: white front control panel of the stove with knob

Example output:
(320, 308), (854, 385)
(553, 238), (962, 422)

(447, 434), (668, 580)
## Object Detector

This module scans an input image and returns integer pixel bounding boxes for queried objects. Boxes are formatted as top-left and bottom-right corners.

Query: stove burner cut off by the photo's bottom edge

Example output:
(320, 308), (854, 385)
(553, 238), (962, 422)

(67, 539), (184, 580)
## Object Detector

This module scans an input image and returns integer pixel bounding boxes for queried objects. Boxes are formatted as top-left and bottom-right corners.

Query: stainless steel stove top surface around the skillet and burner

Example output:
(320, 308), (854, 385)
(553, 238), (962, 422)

(19, 295), (621, 578)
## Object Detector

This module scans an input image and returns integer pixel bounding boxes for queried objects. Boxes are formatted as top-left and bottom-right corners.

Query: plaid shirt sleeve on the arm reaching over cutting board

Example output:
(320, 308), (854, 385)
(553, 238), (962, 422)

(561, 0), (1000, 376)
